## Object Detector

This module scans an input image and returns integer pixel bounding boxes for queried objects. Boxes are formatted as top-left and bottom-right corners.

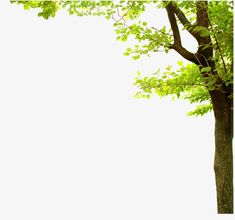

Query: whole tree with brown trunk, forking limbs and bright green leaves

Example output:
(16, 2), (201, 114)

(12, 0), (233, 213)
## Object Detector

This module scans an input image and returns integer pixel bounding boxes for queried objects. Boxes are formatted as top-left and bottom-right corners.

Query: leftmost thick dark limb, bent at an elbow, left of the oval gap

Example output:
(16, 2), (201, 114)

(166, 2), (200, 65)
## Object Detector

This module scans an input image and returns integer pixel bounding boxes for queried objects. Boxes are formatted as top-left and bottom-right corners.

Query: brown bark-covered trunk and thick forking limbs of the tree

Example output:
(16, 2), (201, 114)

(166, 1), (233, 214)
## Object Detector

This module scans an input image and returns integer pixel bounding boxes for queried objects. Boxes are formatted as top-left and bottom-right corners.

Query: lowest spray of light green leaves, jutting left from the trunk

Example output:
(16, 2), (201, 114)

(134, 61), (212, 116)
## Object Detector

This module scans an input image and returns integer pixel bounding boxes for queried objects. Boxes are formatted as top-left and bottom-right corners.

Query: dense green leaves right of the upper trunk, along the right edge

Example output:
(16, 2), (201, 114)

(209, 1), (233, 86)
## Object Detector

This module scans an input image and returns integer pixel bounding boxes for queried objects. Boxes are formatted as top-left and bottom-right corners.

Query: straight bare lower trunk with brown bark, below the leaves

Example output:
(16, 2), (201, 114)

(210, 90), (233, 214)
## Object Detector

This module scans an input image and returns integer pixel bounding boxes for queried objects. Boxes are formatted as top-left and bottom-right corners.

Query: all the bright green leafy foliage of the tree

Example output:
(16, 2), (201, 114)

(11, 0), (233, 116)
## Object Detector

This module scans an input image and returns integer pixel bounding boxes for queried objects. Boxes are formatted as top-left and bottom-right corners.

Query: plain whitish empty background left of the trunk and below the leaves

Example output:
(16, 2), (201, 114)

(0, 2), (232, 220)
